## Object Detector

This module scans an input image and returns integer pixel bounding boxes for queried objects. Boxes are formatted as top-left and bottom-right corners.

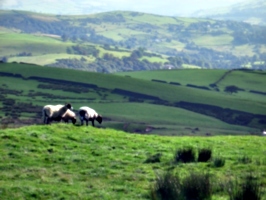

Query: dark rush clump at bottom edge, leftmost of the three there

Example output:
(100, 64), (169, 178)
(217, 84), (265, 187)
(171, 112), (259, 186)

(151, 172), (181, 200)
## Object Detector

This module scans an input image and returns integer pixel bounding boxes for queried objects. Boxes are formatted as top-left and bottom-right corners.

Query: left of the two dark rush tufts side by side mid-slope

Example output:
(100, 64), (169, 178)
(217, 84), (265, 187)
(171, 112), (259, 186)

(175, 147), (195, 163)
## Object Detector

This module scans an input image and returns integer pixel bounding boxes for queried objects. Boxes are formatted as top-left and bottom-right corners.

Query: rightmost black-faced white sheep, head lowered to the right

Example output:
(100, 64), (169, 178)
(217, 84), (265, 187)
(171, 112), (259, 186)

(79, 106), (103, 126)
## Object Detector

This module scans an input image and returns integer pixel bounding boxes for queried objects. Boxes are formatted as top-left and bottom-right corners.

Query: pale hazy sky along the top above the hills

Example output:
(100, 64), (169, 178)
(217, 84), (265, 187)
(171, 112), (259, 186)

(0, 0), (247, 15)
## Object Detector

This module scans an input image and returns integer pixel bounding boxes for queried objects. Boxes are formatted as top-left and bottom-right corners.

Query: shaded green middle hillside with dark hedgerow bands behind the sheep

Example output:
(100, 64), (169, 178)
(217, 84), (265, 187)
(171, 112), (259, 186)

(0, 63), (266, 135)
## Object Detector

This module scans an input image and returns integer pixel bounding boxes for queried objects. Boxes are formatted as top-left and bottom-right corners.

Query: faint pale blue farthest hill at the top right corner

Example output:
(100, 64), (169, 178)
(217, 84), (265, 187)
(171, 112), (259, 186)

(192, 0), (266, 25)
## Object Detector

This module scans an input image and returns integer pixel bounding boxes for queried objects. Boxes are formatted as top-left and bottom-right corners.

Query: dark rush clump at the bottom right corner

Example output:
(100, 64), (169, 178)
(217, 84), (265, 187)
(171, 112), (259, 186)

(228, 174), (262, 200)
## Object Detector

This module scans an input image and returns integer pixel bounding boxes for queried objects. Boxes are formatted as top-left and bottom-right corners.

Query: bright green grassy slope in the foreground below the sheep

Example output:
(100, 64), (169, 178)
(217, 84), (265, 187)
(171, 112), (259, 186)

(0, 124), (266, 200)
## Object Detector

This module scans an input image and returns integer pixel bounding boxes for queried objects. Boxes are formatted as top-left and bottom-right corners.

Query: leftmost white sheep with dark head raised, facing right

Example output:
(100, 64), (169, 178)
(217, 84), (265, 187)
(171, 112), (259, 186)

(42, 103), (71, 124)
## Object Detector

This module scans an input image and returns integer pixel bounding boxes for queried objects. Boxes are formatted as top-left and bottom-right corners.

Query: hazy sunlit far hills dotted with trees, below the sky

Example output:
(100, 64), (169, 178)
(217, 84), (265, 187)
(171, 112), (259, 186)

(0, 11), (266, 73)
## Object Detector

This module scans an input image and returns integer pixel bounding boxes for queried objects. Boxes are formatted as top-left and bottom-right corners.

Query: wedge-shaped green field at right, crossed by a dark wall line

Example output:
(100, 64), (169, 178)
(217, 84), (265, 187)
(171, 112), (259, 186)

(116, 69), (266, 92)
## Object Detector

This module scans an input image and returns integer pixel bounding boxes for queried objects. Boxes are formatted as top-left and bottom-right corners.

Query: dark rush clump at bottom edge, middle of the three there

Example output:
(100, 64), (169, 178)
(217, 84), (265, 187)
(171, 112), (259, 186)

(182, 172), (212, 200)
